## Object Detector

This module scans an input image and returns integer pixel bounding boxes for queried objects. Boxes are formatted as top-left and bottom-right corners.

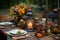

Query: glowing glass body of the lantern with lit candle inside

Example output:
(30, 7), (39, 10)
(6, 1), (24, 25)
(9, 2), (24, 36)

(25, 18), (35, 32)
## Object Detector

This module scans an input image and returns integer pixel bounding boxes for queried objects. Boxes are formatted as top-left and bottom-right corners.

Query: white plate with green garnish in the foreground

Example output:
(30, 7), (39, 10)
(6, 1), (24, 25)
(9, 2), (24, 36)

(7, 29), (28, 36)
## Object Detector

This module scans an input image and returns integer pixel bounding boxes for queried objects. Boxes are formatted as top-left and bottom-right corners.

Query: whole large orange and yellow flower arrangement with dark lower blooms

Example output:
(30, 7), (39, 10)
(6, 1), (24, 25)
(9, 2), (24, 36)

(9, 3), (36, 28)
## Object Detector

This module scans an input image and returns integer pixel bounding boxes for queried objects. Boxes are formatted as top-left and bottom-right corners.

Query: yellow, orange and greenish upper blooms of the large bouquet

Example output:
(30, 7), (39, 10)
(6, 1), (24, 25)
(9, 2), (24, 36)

(9, 3), (28, 16)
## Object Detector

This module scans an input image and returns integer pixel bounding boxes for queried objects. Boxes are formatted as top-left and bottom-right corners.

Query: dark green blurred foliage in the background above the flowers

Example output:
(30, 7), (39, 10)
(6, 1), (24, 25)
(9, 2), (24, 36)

(0, 0), (60, 14)
